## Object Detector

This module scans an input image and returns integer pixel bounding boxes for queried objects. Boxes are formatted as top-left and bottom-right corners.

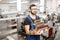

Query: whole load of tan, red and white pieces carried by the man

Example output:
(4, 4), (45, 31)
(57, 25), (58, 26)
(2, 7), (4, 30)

(34, 19), (53, 37)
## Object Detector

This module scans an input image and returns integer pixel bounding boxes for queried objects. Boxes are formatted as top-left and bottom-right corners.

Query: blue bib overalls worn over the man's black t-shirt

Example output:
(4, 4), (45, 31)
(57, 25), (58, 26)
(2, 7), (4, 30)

(27, 15), (40, 40)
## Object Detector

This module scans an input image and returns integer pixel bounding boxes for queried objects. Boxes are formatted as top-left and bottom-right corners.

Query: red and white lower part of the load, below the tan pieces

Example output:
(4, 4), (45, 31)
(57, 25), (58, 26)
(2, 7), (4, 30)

(36, 24), (53, 37)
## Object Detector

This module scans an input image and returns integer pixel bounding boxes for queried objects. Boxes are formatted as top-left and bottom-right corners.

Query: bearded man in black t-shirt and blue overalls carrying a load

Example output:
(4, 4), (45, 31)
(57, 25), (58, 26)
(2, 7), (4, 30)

(24, 4), (43, 40)
